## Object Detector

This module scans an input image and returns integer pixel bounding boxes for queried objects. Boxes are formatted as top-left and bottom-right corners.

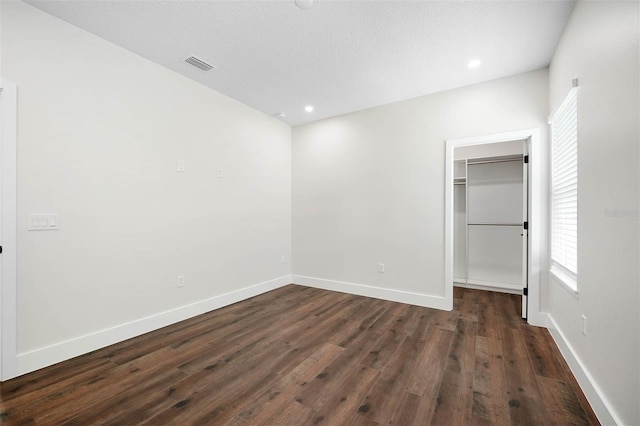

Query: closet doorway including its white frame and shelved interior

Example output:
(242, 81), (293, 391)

(444, 129), (547, 326)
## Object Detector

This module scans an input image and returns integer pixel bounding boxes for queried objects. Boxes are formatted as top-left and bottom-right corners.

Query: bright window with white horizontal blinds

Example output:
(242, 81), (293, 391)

(550, 88), (578, 293)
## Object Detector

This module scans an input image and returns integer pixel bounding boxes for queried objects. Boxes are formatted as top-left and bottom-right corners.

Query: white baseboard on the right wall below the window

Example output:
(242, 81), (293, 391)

(546, 314), (623, 425)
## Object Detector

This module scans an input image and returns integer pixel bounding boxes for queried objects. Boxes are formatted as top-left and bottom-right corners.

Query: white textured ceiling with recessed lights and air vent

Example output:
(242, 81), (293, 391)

(27, 0), (574, 125)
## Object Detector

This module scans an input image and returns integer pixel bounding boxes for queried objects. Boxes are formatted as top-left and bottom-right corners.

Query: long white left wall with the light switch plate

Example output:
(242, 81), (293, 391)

(1, 2), (291, 372)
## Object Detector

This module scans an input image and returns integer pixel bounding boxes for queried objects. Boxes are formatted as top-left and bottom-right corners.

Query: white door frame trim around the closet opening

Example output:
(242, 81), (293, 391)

(444, 129), (546, 326)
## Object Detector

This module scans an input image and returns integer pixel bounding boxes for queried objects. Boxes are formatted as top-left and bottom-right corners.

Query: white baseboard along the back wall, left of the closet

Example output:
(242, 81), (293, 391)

(293, 275), (450, 310)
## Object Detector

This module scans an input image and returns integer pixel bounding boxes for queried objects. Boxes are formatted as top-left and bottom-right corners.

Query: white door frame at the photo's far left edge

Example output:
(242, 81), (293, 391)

(0, 80), (18, 380)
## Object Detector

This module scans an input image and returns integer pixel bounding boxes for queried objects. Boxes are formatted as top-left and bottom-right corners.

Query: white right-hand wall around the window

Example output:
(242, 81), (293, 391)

(548, 1), (640, 425)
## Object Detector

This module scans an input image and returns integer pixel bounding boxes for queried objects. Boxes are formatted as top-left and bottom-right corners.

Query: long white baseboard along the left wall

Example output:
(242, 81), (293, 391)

(15, 275), (291, 379)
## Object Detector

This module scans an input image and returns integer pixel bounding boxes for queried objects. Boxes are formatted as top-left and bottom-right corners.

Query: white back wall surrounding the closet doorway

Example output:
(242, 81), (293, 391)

(293, 70), (548, 306)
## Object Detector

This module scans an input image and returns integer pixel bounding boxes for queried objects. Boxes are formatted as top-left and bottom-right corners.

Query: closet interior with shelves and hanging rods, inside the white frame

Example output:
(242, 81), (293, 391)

(453, 140), (528, 318)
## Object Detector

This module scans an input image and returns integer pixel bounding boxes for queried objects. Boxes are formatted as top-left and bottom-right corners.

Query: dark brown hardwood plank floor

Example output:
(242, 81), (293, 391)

(0, 285), (598, 425)
